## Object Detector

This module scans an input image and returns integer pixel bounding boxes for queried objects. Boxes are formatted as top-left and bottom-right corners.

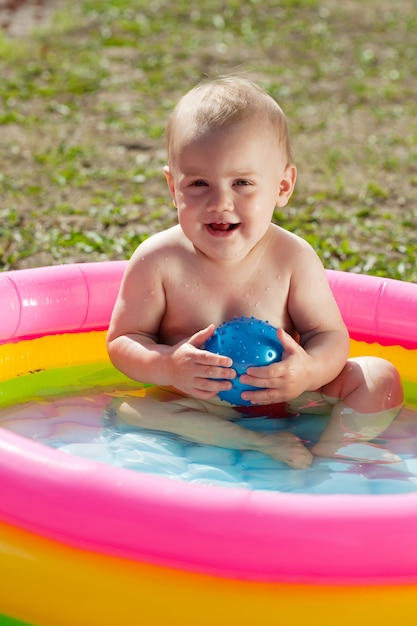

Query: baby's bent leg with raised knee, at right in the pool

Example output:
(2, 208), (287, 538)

(311, 357), (403, 462)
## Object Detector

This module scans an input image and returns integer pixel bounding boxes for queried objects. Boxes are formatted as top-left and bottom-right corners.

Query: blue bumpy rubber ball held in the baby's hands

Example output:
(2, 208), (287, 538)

(204, 317), (284, 406)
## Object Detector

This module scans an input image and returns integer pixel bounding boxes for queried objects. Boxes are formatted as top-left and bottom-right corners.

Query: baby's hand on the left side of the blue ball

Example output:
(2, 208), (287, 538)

(169, 324), (236, 400)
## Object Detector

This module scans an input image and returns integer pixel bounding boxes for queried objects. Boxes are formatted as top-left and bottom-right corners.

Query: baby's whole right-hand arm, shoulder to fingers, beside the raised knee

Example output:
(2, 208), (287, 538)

(237, 239), (349, 404)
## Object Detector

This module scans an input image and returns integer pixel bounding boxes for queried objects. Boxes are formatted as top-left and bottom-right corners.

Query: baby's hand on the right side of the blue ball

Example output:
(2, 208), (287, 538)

(240, 328), (313, 405)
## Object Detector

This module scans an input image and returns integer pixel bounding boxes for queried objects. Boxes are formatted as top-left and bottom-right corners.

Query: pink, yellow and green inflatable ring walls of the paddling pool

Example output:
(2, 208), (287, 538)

(0, 262), (417, 626)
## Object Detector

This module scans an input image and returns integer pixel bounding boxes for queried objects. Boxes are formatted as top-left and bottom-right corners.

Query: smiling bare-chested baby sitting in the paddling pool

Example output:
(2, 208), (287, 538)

(108, 77), (403, 468)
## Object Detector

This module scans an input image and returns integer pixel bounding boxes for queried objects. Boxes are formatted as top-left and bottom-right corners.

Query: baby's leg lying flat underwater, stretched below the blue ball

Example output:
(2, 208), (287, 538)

(112, 389), (312, 469)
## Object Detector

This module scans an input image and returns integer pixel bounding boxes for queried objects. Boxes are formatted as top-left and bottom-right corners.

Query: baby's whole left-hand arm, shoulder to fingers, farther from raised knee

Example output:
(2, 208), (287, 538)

(107, 240), (235, 399)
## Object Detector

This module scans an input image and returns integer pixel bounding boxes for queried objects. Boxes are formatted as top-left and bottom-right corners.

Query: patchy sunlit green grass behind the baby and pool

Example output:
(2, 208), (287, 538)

(0, 0), (417, 281)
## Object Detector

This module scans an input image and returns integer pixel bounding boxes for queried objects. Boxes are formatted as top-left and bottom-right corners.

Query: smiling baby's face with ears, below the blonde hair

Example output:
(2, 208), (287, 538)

(165, 120), (295, 261)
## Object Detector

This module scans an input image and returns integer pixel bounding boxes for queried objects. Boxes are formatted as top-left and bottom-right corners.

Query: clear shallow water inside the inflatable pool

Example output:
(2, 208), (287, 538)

(0, 393), (417, 495)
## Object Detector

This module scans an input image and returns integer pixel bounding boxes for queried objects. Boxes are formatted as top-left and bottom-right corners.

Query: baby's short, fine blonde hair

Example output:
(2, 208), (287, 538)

(166, 76), (292, 163)
